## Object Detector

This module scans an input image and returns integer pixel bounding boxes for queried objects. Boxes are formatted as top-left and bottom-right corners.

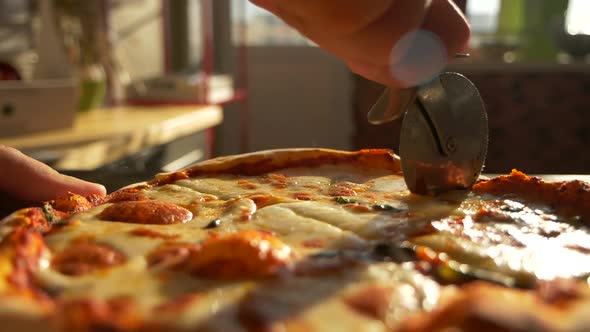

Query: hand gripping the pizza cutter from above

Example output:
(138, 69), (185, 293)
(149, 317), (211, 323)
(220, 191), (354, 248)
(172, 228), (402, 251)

(251, 0), (470, 88)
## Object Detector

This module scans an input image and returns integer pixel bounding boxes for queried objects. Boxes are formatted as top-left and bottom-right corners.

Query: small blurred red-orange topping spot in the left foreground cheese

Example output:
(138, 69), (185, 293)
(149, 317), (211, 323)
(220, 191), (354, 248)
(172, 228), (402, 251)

(51, 243), (126, 276)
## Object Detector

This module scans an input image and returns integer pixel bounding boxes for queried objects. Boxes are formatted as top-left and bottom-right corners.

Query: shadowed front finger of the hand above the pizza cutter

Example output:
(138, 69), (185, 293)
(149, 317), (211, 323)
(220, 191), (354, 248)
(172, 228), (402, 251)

(266, 0), (429, 71)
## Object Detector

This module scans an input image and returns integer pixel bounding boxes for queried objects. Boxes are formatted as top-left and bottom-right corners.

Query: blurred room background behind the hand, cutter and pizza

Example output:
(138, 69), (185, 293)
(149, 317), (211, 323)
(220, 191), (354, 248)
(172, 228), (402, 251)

(0, 0), (590, 188)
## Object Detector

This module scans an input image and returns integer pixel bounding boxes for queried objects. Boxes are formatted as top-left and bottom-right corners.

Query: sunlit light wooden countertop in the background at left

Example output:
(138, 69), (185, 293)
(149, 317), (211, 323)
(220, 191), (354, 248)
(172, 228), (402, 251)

(0, 105), (223, 169)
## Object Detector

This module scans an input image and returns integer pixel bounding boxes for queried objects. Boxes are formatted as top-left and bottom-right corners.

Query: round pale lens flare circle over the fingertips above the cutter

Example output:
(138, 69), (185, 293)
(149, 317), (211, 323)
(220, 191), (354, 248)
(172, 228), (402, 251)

(390, 29), (447, 87)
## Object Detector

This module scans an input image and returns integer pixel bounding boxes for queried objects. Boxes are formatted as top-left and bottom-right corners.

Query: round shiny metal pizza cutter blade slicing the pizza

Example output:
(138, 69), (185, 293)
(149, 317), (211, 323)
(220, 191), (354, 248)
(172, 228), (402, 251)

(399, 73), (488, 195)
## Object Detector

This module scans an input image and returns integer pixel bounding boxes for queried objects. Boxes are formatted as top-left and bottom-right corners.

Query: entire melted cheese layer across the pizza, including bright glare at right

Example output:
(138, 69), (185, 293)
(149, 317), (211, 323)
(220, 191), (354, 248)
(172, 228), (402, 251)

(0, 161), (590, 331)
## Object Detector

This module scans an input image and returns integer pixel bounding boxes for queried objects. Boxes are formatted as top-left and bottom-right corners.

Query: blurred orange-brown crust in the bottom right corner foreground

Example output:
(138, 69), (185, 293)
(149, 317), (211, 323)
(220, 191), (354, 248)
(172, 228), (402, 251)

(396, 282), (588, 332)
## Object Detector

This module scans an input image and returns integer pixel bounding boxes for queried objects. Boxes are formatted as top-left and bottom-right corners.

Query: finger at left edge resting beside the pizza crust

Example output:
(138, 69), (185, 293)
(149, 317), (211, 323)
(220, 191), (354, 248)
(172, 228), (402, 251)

(0, 146), (106, 201)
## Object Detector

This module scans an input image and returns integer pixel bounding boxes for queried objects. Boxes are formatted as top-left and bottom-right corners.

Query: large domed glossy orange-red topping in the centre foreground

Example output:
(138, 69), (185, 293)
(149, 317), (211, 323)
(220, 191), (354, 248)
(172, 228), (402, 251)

(186, 231), (292, 279)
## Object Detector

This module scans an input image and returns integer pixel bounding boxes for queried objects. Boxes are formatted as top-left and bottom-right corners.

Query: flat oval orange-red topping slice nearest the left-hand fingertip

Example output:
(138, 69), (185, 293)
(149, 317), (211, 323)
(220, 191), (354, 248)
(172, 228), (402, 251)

(98, 201), (193, 225)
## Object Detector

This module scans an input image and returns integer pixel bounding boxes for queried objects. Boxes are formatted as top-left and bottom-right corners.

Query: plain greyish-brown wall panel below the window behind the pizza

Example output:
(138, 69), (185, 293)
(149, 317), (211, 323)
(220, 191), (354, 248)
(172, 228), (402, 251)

(218, 46), (353, 154)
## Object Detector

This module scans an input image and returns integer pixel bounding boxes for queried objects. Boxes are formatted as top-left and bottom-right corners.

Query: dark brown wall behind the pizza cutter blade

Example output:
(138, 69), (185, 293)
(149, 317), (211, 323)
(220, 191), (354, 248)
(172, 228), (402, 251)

(354, 64), (590, 174)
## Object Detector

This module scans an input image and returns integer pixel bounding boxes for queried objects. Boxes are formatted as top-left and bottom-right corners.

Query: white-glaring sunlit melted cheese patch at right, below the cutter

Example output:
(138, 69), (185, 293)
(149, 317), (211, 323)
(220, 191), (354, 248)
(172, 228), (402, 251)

(412, 195), (590, 283)
